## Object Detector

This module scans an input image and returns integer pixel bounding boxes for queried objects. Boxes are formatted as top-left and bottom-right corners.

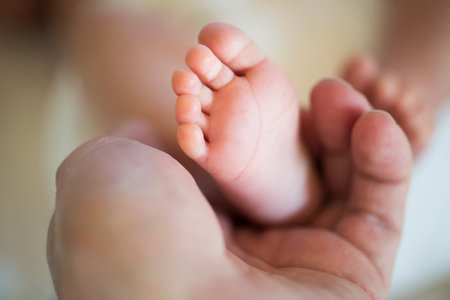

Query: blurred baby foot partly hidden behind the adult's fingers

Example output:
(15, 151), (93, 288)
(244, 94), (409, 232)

(343, 56), (434, 156)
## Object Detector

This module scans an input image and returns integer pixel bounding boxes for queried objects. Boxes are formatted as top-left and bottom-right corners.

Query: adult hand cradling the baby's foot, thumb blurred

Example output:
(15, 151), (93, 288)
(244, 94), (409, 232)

(48, 81), (412, 299)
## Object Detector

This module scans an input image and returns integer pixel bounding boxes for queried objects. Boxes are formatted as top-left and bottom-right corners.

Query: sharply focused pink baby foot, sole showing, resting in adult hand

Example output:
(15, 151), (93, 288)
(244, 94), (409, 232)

(172, 23), (320, 223)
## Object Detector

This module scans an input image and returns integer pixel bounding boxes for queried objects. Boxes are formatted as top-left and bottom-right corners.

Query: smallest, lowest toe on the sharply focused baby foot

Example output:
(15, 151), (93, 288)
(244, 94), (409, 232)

(177, 124), (208, 162)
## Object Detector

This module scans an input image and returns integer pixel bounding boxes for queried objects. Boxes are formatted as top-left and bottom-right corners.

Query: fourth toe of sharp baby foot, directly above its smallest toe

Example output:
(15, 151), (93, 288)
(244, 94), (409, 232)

(175, 95), (208, 132)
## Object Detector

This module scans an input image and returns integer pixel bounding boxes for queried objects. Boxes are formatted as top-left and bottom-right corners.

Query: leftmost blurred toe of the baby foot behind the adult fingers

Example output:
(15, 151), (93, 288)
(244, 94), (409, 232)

(343, 55), (378, 93)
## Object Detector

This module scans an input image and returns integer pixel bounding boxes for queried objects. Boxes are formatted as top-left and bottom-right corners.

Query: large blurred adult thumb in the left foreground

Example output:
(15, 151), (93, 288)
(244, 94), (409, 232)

(48, 137), (224, 299)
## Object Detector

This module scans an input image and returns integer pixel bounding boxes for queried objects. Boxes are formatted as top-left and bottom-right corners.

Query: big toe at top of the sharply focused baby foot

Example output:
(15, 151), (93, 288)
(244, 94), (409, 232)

(199, 23), (266, 74)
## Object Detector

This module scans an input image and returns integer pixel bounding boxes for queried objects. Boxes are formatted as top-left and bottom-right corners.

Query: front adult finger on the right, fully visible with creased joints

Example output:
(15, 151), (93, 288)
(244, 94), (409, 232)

(336, 111), (412, 286)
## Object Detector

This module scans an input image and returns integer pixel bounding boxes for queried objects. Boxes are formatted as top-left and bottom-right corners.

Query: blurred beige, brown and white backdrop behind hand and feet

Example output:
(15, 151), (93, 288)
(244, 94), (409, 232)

(0, 0), (450, 300)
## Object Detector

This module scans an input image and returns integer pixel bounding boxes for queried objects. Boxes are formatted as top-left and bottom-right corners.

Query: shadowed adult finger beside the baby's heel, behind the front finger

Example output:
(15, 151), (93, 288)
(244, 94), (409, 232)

(311, 79), (370, 198)
